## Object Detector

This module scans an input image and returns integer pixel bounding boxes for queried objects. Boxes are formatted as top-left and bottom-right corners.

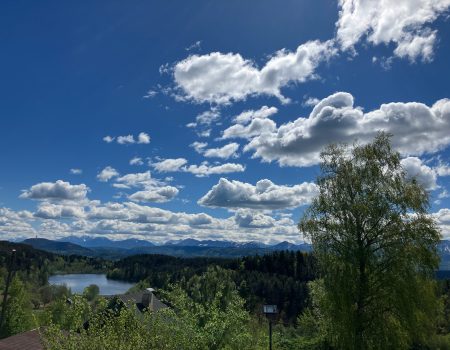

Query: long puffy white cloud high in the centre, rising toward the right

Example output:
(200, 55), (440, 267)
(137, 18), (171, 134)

(173, 41), (336, 104)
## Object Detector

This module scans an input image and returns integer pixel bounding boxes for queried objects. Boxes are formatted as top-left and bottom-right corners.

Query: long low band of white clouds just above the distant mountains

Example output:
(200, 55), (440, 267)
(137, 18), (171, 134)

(0, 201), (301, 243)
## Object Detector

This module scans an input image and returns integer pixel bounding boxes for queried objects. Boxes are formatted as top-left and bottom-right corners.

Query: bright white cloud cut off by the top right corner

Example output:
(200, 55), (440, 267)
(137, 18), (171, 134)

(336, 0), (450, 61)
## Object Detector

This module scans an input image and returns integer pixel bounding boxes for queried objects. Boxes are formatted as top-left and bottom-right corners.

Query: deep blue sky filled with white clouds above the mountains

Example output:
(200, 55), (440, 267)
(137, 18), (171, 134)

(0, 0), (450, 244)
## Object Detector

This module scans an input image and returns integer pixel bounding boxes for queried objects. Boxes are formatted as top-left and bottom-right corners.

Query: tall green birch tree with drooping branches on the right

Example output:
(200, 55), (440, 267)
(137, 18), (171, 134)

(299, 133), (440, 350)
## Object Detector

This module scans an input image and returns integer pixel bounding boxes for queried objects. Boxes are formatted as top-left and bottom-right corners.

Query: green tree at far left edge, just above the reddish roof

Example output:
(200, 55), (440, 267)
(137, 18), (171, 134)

(0, 277), (33, 338)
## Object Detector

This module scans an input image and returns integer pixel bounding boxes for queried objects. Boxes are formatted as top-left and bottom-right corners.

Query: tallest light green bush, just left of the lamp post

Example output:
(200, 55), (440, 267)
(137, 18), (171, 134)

(166, 267), (268, 350)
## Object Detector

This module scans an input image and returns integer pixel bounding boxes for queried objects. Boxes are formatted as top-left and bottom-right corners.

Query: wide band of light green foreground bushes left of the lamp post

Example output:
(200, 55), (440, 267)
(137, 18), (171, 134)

(43, 268), (267, 350)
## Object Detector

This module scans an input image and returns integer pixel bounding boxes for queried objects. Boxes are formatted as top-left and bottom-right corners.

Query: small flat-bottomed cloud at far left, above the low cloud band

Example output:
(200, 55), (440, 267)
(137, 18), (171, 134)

(19, 180), (89, 201)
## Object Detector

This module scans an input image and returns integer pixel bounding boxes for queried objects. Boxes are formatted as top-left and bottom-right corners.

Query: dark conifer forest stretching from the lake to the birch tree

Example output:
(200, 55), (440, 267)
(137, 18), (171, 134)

(108, 251), (316, 324)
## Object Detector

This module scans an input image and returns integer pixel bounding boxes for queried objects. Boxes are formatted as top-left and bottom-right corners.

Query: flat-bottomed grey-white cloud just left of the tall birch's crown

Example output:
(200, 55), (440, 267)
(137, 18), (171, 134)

(198, 178), (318, 210)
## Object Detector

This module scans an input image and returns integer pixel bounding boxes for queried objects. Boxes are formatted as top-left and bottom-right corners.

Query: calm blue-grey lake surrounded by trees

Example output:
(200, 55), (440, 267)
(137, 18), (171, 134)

(48, 273), (134, 295)
